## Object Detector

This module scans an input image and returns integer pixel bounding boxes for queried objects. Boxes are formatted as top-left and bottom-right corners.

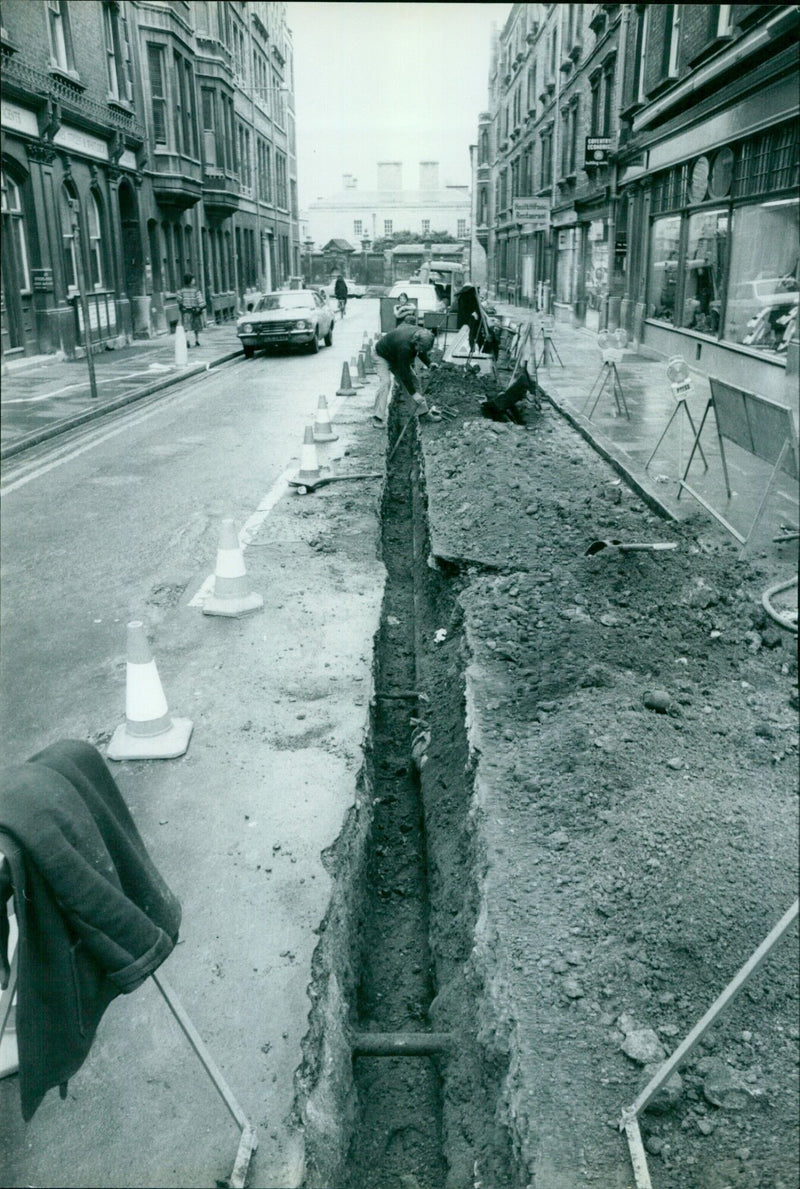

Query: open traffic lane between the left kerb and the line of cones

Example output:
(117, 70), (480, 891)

(0, 302), (374, 761)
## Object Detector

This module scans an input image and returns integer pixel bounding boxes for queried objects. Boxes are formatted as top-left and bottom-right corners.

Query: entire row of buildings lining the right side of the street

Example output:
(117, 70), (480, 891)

(473, 4), (800, 404)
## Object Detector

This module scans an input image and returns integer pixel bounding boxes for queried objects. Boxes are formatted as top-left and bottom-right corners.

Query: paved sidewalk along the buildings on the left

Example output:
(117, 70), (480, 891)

(0, 322), (240, 458)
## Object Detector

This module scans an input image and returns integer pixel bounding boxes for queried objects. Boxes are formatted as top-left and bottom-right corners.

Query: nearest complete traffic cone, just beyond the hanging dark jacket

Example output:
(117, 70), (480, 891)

(106, 619), (193, 760)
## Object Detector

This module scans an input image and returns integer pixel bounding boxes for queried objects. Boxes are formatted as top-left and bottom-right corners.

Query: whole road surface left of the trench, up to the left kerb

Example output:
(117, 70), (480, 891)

(0, 302), (385, 1189)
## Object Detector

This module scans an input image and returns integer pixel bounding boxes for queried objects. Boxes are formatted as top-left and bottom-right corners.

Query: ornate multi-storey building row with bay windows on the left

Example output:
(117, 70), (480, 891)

(0, 0), (300, 358)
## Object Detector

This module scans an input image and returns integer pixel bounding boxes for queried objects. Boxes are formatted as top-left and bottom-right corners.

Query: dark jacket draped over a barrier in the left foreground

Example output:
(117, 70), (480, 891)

(0, 740), (181, 1120)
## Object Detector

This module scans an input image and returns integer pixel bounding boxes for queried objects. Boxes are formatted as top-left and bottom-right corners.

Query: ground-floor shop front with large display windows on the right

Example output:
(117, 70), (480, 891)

(640, 112), (800, 408)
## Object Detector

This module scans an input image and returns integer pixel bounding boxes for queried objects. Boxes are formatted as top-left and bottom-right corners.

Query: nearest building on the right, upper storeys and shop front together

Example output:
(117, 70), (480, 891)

(617, 5), (800, 409)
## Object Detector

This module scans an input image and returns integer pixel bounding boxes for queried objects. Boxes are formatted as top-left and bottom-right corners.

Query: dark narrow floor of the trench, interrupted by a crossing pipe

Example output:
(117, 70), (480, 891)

(346, 404), (447, 1189)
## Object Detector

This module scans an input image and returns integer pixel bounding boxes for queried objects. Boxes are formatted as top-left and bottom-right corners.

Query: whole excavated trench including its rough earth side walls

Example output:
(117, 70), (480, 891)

(296, 405), (512, 1189)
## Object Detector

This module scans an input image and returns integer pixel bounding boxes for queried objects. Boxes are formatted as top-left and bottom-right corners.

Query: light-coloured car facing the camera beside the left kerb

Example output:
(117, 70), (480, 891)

(237, 289), (334, 359)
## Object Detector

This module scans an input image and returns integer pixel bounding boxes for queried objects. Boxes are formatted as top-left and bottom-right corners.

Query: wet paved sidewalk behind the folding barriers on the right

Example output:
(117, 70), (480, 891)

(496, 302), (798, 566)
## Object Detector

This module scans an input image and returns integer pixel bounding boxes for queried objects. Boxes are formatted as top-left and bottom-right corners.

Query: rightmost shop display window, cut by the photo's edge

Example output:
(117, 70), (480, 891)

(724, 197), (800, 356)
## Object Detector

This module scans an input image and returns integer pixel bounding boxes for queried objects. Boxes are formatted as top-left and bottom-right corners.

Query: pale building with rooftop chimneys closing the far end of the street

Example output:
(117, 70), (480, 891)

(301, 161), (471, 250)
